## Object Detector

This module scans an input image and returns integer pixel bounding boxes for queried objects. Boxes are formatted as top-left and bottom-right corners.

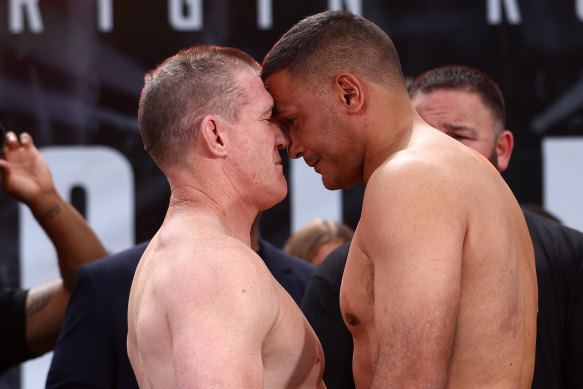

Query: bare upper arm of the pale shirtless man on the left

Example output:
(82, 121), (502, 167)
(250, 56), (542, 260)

(164, 250), (278, 388)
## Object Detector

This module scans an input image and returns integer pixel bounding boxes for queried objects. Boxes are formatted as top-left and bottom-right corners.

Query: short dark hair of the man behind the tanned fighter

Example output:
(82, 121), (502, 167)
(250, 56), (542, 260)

(408, 65), (506, 135)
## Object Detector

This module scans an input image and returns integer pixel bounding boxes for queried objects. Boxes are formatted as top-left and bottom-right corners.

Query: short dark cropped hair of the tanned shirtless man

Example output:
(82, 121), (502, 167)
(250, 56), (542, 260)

(261, 11), (404, 88)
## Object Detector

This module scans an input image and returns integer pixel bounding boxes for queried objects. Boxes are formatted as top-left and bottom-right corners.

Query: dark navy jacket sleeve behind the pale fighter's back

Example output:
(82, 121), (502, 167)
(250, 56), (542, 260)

(47, 267), (115, 389)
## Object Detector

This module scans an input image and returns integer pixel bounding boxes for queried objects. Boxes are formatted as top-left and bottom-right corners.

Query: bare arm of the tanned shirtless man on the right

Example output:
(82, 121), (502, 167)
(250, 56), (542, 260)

(359, 168), (466, 388)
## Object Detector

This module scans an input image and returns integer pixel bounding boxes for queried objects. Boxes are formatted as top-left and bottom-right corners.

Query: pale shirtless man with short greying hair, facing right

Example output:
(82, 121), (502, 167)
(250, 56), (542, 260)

(128, 46), (324, 389)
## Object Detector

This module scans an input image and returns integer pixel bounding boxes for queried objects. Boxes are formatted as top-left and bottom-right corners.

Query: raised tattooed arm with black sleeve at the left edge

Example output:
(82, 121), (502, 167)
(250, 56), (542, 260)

(0, 132), (107, 372)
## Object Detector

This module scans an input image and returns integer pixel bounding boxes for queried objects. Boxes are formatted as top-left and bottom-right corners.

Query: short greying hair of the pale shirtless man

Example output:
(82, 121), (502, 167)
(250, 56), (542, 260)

(138, 45), (260, 166)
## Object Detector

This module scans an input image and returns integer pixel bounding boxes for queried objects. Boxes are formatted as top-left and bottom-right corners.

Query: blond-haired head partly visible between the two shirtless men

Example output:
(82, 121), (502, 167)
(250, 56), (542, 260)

(283, 219), (354, 266)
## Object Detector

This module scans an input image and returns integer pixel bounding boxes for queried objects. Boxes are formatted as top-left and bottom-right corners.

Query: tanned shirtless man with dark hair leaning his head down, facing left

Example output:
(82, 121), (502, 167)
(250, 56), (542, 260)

(262, 11), (537, 388)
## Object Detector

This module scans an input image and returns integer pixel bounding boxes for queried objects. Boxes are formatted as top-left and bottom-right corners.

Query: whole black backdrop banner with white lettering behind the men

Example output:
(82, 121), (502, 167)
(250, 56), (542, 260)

(0, 0), (583, 388)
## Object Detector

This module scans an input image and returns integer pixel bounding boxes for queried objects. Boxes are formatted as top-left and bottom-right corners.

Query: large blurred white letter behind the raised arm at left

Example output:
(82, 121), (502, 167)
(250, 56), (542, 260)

(18, 146), (135, 389)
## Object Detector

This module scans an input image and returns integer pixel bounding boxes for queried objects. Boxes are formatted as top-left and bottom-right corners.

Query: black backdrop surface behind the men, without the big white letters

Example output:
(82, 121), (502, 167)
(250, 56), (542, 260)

(0, 0), (583, 384)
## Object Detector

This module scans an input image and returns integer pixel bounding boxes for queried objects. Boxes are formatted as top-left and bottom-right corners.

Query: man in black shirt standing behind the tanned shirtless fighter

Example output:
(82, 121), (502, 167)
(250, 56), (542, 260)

(302, 66), (583, 389)
